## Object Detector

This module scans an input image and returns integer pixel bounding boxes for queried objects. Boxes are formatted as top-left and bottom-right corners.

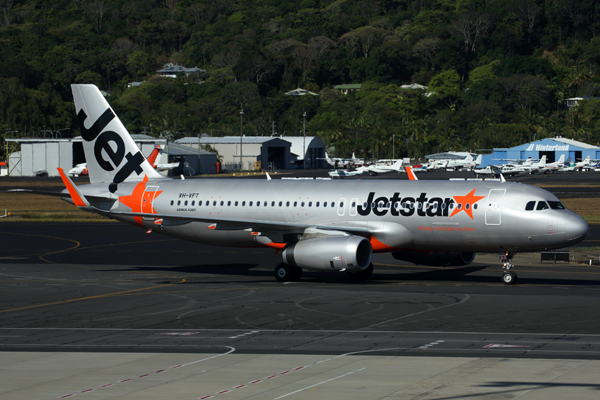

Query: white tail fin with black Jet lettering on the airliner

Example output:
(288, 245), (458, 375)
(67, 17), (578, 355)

(71, 85), (164, 193)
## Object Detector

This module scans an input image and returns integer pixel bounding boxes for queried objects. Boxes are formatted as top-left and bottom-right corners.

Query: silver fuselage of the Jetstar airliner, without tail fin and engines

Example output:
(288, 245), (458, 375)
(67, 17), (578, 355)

(74, 179), (588, 252)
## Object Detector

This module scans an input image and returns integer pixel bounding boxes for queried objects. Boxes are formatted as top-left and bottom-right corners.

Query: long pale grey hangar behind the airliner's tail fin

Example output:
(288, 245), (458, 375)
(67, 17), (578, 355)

(5, 134), (217, 176)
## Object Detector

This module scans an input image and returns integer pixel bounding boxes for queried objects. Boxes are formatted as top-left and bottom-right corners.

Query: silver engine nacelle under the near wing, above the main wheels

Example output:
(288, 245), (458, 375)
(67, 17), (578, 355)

(283, 236), (373, 272)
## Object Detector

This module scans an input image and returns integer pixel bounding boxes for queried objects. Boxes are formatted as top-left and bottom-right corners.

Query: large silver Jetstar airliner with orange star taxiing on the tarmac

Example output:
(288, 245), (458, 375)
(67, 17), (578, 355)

(25, 85), (589, 284)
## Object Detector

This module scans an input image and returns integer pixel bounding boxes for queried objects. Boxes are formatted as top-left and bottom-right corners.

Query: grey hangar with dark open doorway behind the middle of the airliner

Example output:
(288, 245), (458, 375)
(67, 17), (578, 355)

(176, 136), (327, 170)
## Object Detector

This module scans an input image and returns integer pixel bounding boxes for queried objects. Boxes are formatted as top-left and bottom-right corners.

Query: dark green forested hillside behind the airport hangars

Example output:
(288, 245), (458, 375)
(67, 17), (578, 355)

(0, 0), (600, 158)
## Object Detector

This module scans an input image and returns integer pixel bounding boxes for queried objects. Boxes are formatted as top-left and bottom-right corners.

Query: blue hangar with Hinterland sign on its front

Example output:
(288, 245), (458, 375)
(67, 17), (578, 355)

(481, 137), (600, 166)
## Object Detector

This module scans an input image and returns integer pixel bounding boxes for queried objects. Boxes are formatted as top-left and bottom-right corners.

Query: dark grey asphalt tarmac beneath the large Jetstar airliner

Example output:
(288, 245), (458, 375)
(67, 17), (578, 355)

(0, 173), (600, 399)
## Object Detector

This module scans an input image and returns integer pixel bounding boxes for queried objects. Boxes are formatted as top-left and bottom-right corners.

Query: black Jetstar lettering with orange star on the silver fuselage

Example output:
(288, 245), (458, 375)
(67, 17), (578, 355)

(357, 189), (485, 219)
